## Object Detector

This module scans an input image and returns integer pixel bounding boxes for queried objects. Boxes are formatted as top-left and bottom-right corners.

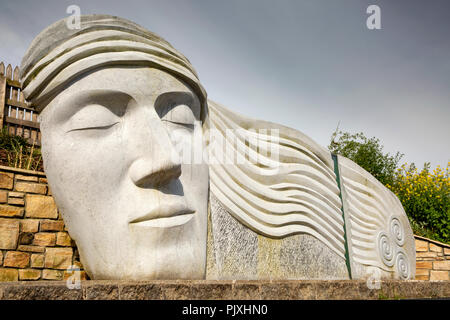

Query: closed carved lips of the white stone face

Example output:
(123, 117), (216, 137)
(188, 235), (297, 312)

(130, 204), (195, 228)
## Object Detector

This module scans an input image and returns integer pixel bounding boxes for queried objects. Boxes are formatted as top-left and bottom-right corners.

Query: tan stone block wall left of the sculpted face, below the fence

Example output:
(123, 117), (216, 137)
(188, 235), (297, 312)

(0, 166), (86, 281)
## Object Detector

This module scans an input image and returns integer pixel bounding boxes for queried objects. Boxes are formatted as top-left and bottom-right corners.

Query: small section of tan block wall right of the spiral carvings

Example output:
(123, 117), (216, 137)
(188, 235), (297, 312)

(414, 236), (450, 280)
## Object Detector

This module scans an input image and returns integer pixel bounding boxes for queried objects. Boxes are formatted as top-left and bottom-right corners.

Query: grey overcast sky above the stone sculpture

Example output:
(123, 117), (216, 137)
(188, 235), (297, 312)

(0, 0), (450, 167)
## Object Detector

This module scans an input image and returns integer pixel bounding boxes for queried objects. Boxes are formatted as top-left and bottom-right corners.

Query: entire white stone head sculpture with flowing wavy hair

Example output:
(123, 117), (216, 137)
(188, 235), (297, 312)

(21, 15), (415, 280)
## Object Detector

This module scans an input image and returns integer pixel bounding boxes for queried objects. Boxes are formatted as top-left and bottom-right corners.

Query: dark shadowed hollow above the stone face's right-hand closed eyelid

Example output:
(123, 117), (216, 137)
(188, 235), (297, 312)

(155, 91), (200, 119)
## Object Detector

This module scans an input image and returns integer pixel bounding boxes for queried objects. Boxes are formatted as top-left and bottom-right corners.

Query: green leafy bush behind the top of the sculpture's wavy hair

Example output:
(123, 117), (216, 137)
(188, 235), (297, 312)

(328, 129), (403, 185)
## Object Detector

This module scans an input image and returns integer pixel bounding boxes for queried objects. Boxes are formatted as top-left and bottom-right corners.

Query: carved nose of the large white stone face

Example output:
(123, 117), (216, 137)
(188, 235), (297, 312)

(129, 109), (181, 188)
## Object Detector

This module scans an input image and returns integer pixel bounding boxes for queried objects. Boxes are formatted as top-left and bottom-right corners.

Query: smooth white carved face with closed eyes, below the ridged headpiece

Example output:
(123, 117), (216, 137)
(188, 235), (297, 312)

(41, 67), (209, 280)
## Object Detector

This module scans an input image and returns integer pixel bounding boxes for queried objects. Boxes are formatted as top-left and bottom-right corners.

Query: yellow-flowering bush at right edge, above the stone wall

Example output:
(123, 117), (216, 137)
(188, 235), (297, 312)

(386, 162), (450, 243)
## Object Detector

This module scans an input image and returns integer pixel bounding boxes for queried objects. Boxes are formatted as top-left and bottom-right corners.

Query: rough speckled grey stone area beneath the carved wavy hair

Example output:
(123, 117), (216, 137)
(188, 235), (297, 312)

(207, 195), (348, 280)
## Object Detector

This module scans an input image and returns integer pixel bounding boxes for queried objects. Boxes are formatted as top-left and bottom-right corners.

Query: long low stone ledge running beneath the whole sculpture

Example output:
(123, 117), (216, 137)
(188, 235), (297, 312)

(0, 280), (450, 300)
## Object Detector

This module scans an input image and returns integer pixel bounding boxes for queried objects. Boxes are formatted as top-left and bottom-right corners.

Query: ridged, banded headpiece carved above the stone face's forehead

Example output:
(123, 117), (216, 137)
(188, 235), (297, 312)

(20, 15), (207, 119)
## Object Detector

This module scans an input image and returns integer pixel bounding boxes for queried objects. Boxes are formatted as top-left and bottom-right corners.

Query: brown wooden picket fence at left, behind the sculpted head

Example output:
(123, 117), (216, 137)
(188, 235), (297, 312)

(0, 62), (41, 146)
